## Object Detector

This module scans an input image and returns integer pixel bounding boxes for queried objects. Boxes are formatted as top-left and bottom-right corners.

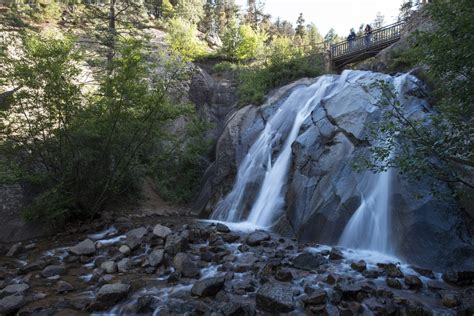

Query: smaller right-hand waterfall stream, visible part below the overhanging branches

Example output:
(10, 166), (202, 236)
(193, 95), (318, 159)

(339, 169), (393, 254)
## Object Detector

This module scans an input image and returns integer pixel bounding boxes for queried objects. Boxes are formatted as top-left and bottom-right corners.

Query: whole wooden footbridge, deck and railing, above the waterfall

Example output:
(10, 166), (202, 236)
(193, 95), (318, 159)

(330, 22), (404, 68)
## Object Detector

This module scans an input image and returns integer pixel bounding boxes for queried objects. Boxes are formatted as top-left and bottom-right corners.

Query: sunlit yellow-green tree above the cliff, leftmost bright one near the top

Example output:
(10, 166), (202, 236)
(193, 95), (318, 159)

(166, 18), (207, 61)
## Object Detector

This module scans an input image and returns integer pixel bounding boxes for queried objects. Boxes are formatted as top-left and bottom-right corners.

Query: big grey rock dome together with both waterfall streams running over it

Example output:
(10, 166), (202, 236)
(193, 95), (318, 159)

(197, 71), (474, 268)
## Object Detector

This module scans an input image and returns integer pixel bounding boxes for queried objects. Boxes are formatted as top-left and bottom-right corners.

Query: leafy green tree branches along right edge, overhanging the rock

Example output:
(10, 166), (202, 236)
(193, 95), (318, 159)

(362, 0), (474, 194)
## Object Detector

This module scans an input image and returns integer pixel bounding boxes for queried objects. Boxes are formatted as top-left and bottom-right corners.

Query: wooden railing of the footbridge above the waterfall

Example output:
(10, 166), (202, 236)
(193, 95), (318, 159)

(331, 21), (405, 59)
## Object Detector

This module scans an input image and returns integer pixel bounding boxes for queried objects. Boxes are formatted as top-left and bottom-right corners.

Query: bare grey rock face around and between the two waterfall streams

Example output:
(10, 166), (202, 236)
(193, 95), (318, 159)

(197, 72), (474, 269)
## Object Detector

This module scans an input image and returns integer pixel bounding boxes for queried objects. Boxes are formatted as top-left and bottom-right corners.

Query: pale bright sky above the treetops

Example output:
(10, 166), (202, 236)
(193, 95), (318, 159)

(236, 0), (403, 36)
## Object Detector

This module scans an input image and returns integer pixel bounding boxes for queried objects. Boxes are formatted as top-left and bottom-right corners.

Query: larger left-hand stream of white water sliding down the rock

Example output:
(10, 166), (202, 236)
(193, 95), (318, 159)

(211, 72), (363, 227)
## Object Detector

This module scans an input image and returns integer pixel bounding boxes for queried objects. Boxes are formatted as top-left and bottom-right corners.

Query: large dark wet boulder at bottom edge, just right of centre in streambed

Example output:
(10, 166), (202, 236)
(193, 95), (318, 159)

(256, 283), (294, 313)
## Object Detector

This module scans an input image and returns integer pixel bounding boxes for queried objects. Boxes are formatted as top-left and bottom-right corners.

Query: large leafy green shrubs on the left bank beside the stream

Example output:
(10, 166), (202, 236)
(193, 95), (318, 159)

(0, 36), (198, 223)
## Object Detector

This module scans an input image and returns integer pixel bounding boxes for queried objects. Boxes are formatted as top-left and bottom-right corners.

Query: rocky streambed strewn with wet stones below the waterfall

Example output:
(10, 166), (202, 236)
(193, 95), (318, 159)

(0, 217), (474, 315)
